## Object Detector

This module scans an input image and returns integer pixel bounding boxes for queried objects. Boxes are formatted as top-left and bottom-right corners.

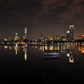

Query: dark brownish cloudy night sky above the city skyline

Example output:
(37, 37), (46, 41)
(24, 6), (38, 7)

(0, 0), (84, 39)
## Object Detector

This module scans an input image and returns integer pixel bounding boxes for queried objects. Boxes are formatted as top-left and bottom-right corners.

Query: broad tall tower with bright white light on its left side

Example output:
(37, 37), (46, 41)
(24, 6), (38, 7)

(66, 25), (74, 41)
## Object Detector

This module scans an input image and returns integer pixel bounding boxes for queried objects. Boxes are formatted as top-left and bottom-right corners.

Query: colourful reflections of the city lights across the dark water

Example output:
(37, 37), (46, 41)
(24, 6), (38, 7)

(1, 43), (84, 63)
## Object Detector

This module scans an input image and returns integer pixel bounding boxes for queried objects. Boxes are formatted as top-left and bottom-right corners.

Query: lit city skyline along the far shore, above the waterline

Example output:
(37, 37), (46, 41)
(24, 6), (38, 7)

(1, 24), (84, 40)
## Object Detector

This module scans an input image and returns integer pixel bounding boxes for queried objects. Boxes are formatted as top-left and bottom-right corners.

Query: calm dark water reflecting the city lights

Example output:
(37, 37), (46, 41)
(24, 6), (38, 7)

(0, 44), (84, 84)
